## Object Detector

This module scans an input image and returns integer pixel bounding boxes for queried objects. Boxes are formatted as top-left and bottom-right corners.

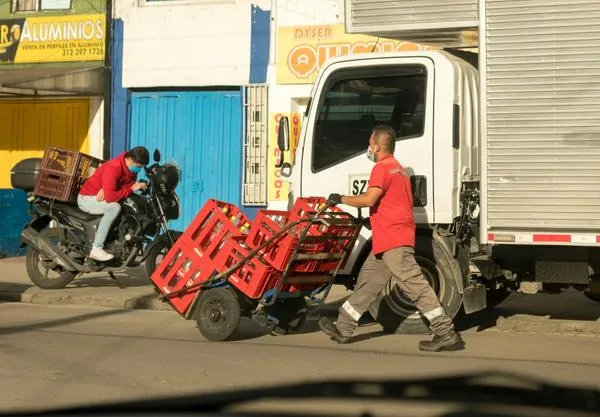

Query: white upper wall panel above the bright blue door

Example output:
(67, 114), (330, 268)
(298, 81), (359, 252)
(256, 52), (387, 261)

(114, 0), (270, 88)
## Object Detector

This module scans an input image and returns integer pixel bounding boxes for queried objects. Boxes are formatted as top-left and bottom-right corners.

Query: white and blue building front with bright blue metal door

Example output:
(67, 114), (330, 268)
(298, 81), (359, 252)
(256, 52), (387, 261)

(111, 0), (271, 230)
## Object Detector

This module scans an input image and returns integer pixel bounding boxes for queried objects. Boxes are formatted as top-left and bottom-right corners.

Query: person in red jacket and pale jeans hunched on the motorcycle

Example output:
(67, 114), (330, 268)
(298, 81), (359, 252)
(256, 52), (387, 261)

(77, 146), (150, 262)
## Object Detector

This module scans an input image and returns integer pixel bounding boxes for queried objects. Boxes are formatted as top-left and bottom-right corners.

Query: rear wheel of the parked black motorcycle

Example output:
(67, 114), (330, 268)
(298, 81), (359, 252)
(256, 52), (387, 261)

(25, 229), (76, 290)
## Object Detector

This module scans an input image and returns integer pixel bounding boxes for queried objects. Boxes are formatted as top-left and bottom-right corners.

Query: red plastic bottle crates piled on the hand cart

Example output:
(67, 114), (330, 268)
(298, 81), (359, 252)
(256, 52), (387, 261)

(151, 197), (354, 314)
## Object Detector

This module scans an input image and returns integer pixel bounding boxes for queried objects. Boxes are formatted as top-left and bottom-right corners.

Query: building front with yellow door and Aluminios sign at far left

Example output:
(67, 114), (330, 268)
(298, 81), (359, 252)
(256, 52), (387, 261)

(0, 0), (107, 256)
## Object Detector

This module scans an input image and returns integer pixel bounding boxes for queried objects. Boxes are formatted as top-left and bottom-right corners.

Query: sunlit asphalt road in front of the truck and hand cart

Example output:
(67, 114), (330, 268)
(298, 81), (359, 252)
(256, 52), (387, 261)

(0, 303), (600, 411)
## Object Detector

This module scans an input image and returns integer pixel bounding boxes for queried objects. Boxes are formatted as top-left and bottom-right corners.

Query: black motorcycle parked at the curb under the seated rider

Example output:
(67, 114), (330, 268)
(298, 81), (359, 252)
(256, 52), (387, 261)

(13, 149), (181, 289)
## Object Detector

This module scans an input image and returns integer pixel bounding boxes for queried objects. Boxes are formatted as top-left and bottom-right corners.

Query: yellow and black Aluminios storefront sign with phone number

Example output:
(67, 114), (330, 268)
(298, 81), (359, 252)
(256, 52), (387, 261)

(0, 14), (106, 64)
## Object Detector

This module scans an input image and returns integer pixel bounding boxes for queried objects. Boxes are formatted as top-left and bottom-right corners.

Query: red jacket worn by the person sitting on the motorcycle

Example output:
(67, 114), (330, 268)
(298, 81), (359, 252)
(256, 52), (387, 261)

(79, 152), (137, 203)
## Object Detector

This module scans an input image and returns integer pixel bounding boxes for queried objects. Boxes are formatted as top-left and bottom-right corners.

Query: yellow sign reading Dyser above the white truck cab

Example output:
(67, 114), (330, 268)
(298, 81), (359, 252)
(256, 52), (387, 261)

(277, 25), (435, 84)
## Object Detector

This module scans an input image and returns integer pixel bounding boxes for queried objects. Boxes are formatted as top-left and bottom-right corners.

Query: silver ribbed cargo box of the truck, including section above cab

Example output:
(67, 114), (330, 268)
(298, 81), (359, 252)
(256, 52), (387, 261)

(346, 0), (600, 245)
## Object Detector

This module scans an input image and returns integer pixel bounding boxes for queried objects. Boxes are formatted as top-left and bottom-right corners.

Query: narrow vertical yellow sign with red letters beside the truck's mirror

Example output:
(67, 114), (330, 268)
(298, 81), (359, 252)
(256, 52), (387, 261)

(267, 113), (302, 201)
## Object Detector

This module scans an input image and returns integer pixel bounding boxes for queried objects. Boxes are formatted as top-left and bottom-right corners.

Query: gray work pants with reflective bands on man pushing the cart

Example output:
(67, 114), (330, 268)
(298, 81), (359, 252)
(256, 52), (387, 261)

(336, 247), (454, 337)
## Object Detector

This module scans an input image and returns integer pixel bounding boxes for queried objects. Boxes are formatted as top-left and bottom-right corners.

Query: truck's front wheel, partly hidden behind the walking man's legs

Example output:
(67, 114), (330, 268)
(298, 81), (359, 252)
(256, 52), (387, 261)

(369, 238), (463, 334)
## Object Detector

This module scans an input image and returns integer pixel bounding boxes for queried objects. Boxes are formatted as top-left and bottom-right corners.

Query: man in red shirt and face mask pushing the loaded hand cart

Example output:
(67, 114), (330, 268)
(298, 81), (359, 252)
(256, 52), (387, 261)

(319, 126), (464, 352)
